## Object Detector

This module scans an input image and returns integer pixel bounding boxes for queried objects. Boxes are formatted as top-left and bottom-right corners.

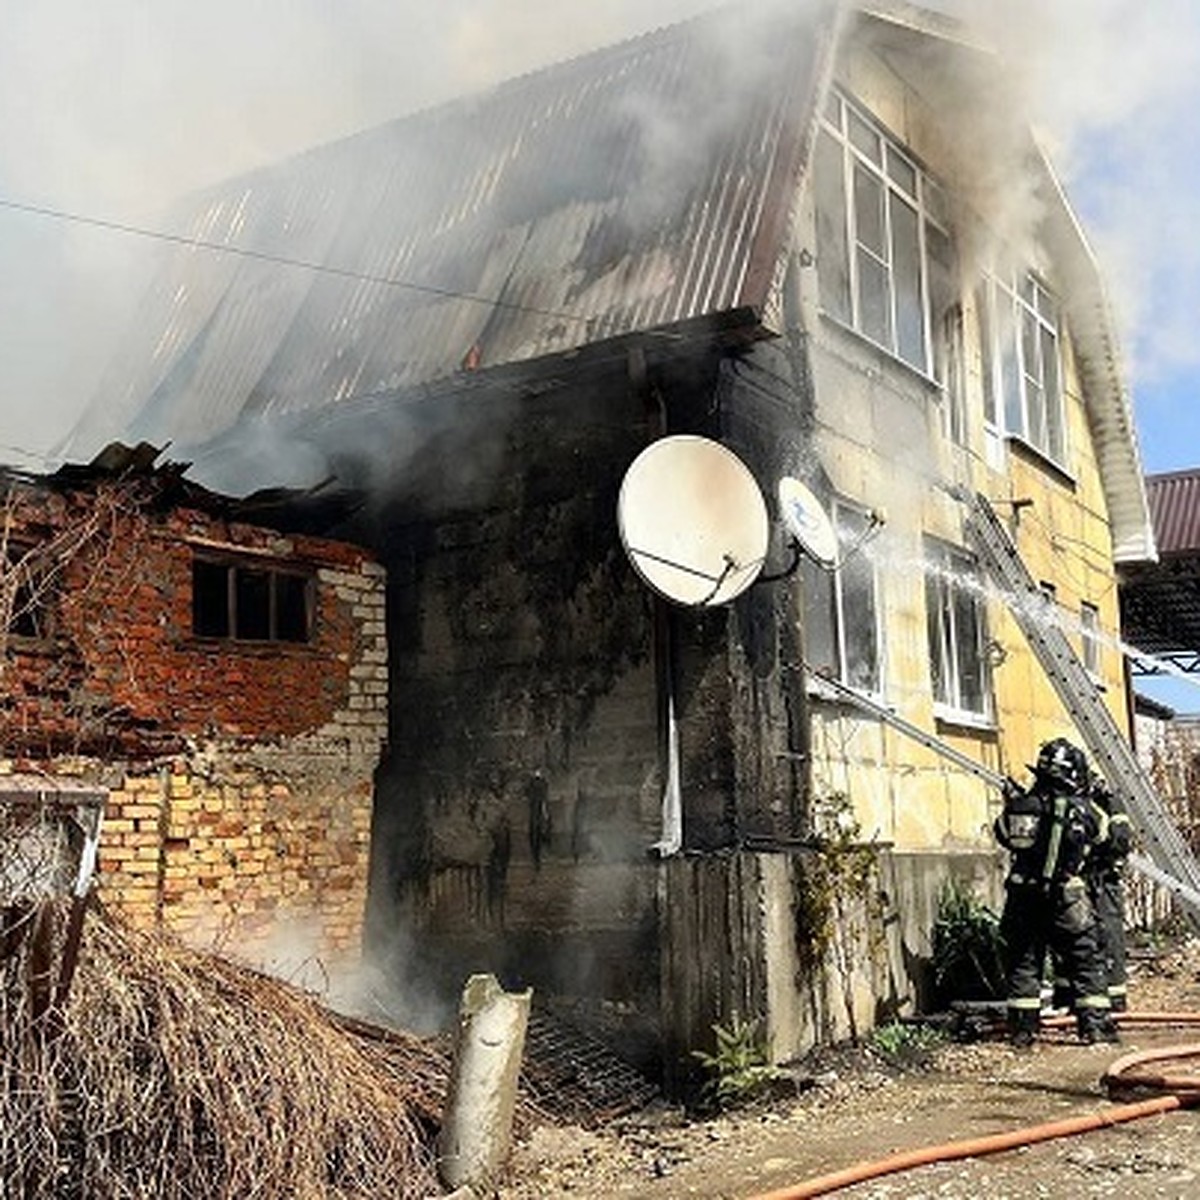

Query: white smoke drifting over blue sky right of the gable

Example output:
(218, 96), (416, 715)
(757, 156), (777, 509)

(943, 0), (1200, 436)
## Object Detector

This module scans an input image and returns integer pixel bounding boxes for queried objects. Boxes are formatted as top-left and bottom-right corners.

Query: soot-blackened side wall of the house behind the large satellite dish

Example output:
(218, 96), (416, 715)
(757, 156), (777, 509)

(366, 331), (820, 1060)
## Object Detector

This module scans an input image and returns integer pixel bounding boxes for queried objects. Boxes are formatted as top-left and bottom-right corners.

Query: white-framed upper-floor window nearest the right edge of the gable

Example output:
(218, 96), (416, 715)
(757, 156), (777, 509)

(978, 272), (1067, 466)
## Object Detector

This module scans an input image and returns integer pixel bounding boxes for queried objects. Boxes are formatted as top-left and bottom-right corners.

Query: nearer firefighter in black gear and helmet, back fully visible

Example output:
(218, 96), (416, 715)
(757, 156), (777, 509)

(995, 738), (1116, 1045)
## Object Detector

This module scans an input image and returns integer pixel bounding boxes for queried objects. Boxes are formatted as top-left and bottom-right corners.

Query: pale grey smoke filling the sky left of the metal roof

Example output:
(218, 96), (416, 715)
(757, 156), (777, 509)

(0, 0), (712, 461)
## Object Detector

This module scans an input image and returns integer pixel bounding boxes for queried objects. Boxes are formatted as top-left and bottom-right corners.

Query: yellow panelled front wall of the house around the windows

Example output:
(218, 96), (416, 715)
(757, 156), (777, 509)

(796, 35), (1126, 851)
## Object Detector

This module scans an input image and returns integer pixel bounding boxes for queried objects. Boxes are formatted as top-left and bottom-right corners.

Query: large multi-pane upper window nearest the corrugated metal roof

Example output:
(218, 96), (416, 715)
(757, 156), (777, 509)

(814, 95), (954, 376)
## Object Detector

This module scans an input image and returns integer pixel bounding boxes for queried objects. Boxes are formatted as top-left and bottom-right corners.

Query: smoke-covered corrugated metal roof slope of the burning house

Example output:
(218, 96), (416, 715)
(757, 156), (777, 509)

(68, 6), (828, 456)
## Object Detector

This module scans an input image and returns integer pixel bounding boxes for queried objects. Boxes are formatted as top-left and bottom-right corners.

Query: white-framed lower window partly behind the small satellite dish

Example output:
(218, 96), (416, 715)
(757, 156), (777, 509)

(802, 500), (882, 692)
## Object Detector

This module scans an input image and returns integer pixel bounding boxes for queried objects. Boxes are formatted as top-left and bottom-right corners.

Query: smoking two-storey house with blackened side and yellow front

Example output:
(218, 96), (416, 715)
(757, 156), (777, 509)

(63, 4), (1154, 1070)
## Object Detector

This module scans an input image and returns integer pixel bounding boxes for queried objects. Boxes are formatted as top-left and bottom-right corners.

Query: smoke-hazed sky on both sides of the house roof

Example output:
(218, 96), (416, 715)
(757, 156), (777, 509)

(0, 0), (1200, 710)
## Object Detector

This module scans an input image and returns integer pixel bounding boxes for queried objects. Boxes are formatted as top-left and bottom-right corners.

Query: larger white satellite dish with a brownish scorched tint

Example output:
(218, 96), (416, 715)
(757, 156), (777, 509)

(617, 434), (769, 606)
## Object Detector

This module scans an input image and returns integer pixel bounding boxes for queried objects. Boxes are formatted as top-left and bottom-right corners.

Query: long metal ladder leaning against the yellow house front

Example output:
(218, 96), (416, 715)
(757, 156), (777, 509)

(955, 491), (1200, 926)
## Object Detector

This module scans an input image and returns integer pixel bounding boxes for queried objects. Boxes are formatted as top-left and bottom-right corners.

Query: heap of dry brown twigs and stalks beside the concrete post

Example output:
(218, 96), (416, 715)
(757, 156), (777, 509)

(0, 910), (448, 1200)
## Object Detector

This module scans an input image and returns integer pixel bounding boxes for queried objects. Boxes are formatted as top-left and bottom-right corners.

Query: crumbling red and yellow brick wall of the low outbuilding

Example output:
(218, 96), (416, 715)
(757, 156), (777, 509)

(0, 468), (388, 964)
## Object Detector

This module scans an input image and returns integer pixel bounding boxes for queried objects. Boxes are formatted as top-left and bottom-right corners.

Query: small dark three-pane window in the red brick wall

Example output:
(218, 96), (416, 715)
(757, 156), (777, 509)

(192, 558), (312, 642)
